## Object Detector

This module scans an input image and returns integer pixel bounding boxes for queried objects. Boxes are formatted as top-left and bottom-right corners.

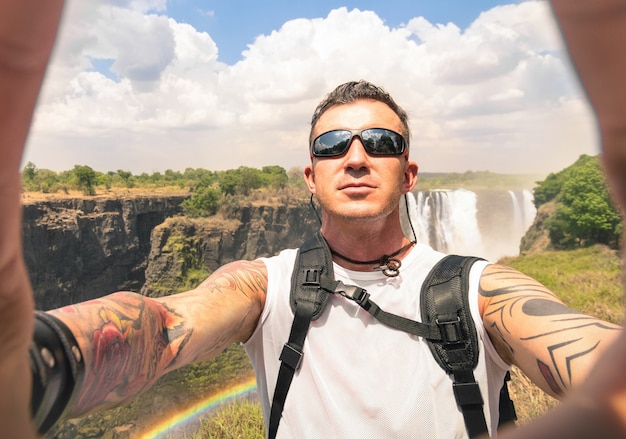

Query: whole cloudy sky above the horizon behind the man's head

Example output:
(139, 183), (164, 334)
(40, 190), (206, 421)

(23, 0), (599, 174)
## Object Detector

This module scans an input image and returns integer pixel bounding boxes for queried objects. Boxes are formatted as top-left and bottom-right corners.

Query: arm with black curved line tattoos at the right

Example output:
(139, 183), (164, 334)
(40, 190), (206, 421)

(479, 265), (620, 397)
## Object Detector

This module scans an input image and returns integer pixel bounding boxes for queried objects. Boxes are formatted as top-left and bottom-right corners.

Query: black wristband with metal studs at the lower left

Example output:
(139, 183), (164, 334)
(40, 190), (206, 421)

(30, 311), (85, 434)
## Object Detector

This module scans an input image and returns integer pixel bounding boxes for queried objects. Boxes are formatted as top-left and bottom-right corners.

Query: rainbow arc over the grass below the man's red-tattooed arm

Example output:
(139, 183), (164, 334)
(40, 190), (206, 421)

(139, 377), (256, 439)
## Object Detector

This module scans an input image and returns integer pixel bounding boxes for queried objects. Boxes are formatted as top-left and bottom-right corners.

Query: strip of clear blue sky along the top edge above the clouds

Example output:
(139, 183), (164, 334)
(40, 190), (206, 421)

(167, 0), (516, 64)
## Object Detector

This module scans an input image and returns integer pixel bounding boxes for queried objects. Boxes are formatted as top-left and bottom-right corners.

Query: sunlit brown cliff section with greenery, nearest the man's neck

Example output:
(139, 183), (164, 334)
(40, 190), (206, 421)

(141, 202), (319, 296)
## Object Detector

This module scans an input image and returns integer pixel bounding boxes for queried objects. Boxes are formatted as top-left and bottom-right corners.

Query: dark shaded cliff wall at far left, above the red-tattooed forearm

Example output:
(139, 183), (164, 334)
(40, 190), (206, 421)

(23, 195), (186, 309)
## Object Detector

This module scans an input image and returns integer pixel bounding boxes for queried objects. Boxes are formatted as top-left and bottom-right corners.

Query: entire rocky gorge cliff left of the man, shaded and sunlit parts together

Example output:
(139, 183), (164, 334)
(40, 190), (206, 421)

(23, 195), (319, 310)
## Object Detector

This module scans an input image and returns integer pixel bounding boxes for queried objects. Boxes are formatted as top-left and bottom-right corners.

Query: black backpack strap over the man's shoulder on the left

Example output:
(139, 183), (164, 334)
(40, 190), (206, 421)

(268, 232), (337, 439)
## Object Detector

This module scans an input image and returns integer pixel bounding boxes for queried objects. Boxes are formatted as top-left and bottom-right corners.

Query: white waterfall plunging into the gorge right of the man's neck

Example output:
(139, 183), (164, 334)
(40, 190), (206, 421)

(401, 189), (536, 261)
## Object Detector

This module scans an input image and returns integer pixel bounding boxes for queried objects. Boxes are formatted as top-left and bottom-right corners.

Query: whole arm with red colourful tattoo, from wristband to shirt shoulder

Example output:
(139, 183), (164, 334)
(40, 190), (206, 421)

(47, 261), (267, 417)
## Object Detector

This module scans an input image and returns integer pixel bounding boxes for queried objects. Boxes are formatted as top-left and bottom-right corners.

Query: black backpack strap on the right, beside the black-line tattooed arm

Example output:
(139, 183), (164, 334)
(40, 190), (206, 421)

(421, 255), (488, 437)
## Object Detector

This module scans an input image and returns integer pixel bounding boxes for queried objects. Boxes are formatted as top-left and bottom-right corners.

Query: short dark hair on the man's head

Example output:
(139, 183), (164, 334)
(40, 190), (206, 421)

(309, 80), (411, 145)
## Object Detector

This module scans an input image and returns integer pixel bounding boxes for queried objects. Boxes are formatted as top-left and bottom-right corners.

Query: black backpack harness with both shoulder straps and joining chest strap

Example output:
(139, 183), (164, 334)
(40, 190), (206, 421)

(268, 232), (517, 439)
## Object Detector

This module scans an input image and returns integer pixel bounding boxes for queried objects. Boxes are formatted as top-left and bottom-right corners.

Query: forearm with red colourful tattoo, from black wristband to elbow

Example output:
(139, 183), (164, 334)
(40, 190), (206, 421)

(50, 293), (186, 417)
